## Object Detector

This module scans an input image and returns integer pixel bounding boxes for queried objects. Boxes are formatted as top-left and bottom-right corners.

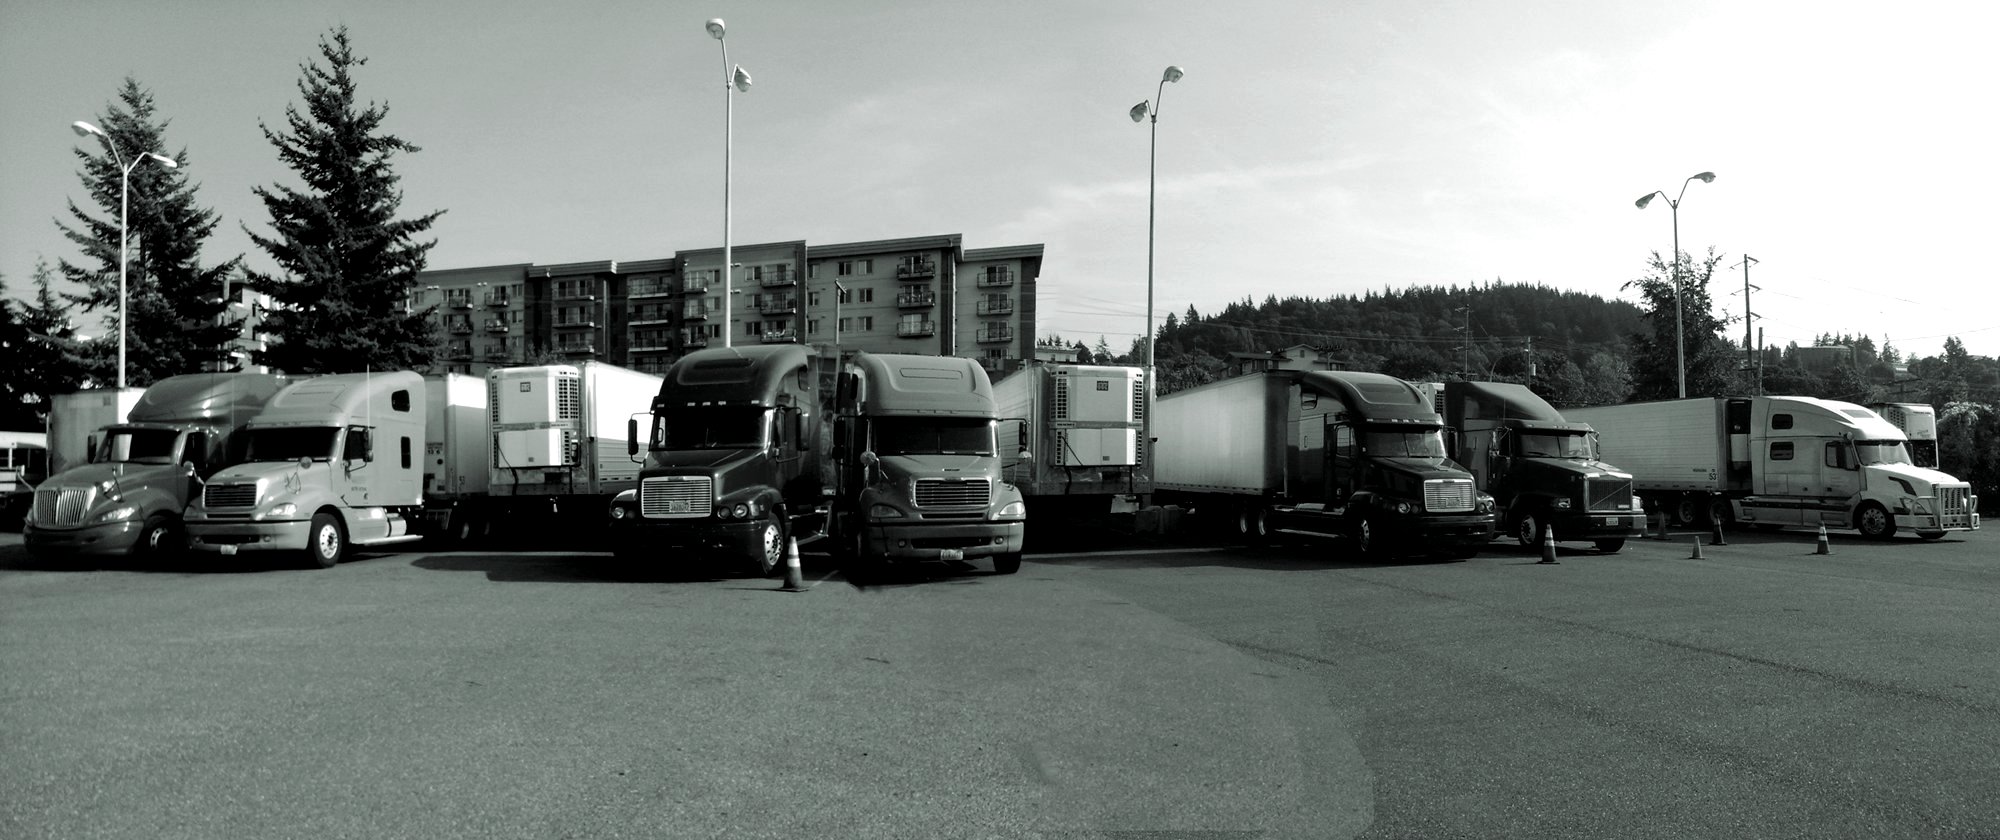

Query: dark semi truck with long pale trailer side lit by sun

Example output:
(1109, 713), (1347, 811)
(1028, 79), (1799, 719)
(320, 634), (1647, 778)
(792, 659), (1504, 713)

(1152, 370), (1494, 558)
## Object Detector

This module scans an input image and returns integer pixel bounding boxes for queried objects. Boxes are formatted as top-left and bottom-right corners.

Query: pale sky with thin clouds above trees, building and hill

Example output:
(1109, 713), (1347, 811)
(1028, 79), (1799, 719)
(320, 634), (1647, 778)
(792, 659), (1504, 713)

(0, 0), (2000, 356)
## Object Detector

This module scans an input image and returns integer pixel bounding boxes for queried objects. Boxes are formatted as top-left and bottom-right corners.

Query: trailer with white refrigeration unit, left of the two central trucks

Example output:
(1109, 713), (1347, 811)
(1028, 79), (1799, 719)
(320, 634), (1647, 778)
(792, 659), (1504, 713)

(482, 362), (664, 542)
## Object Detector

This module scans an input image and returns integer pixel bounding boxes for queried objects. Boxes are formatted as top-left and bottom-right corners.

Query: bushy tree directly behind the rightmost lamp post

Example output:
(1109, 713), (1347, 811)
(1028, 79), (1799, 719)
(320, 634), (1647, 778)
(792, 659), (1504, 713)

(1624, 248), (1740, 400)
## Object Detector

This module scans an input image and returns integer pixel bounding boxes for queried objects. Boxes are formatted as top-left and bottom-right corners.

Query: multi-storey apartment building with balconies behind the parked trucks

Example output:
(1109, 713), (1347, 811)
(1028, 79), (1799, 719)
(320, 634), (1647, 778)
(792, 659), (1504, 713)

(408, 234), (1042, 374)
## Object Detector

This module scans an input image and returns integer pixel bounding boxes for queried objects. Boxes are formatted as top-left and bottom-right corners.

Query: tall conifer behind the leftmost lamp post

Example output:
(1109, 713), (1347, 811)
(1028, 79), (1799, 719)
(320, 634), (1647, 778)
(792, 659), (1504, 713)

(56, 76), (240, 386)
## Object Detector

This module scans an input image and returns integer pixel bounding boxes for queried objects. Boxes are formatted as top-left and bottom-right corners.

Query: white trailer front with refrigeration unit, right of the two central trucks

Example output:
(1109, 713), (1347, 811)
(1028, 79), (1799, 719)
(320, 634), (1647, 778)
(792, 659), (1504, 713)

(994, 364), (1152, 520)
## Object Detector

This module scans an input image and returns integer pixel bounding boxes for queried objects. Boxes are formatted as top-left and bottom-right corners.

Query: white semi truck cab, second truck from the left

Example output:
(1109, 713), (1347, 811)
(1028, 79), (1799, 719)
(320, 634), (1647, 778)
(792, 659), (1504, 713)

(186, 370), (426, 568)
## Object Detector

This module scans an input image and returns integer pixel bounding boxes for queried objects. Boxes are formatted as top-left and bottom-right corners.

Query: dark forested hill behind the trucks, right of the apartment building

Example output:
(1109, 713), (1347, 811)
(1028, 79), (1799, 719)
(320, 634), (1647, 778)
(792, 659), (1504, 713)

(1132, 282), (1644, 398)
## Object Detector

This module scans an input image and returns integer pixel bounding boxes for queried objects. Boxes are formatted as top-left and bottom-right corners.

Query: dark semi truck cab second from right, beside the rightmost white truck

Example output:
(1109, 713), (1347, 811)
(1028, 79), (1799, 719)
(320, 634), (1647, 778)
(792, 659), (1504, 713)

(1434, 382), (1646, 554)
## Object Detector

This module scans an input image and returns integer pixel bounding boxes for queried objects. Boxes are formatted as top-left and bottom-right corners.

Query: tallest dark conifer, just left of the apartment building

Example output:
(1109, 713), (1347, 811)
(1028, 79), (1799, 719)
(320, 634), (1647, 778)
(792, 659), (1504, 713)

(246, 26), (442, 374)
